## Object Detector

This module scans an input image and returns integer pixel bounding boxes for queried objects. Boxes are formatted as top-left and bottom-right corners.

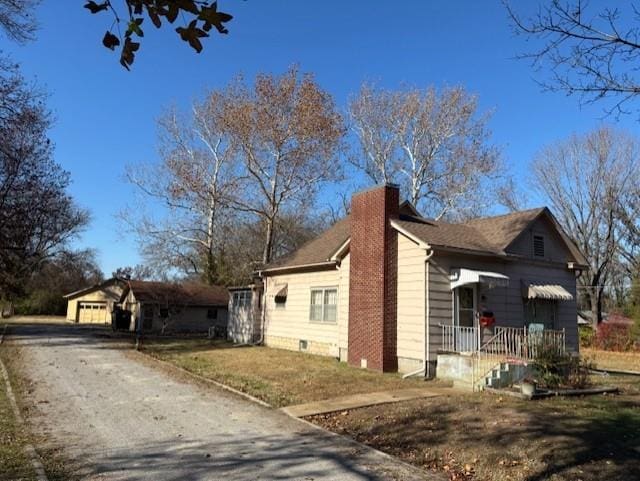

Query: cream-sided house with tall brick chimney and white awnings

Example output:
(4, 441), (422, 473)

(232, 185), (586, 382)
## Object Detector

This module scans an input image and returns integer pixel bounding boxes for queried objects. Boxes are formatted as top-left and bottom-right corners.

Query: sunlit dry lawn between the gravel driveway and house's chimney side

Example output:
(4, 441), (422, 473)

(143, 339), (425, 407)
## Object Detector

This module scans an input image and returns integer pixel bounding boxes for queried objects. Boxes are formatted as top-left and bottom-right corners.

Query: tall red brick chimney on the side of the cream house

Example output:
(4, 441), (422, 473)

(348, 184), (400, 371)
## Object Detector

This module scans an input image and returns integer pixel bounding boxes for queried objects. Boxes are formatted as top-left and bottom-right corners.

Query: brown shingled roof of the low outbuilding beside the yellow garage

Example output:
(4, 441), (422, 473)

(123, 280), (229, 307)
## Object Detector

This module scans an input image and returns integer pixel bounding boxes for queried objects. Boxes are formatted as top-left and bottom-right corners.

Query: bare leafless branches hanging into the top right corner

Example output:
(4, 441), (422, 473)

(510, 0), (640, 113)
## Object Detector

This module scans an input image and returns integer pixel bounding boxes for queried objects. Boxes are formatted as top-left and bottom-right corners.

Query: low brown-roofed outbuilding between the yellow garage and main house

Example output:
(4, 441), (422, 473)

(118, 280), (229, 335)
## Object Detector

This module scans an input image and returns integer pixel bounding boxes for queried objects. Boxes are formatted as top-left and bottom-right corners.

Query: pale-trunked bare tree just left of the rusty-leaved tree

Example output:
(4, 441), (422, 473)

(126, 92), (236, 284)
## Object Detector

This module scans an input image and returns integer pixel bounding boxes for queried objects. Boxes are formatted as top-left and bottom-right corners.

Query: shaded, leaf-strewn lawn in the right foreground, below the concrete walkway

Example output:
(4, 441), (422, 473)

(310, 376), (640, 481)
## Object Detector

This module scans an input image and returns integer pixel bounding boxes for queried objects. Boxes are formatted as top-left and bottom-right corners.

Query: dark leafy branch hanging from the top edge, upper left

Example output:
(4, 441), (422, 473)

(84, 0), (233, 70)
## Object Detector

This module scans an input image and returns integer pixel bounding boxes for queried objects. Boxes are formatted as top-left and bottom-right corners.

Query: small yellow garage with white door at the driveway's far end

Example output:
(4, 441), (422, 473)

(64, 277), (126, 324)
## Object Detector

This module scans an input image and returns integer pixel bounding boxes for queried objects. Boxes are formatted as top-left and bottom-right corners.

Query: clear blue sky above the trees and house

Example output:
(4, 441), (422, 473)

(0, 0), (637, 275)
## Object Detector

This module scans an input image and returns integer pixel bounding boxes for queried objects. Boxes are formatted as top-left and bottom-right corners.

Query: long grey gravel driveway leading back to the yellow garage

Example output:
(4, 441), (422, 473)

(9, 325), (441, 481)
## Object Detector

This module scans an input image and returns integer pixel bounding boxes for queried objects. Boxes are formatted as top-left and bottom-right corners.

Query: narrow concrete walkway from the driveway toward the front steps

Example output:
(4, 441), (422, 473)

(281, 387), (455, 418)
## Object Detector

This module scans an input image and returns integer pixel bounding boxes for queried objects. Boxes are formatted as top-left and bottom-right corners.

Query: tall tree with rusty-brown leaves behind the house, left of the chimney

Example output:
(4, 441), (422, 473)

(226, 68), (344, 264)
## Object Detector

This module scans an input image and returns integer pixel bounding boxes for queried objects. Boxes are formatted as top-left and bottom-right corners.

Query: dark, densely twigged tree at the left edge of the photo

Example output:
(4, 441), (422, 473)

(0, 61), (89, 297)
